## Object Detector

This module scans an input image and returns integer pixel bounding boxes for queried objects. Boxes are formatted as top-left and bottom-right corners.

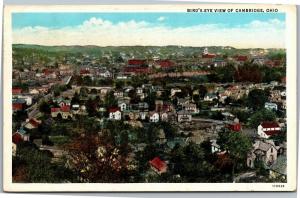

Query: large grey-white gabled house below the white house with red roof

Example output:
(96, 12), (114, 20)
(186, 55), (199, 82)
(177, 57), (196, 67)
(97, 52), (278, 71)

(247, 140), (277, 168)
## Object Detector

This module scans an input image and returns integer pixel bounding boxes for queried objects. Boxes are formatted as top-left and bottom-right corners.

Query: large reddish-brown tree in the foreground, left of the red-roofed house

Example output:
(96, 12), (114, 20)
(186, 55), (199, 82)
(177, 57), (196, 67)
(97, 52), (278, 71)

(66, 133), (128, 183)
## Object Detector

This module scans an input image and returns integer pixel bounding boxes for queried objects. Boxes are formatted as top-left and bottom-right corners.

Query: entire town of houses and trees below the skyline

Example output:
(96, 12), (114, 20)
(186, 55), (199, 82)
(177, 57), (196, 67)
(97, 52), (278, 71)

(12, 45), (287, 183)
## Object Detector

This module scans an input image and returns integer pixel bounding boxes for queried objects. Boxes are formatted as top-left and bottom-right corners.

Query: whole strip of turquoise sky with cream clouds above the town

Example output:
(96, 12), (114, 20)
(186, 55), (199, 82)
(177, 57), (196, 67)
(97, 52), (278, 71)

(12, 12), (285, 48)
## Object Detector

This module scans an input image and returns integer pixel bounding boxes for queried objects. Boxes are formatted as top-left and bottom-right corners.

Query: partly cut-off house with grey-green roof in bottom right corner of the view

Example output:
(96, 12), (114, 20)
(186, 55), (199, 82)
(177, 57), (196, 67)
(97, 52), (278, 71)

(269, 155), (287, 180)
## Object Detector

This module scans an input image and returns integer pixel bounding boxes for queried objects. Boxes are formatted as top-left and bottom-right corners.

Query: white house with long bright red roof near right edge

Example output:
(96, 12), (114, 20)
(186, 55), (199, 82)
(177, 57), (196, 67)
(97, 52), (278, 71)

(257, 122), (281, 139)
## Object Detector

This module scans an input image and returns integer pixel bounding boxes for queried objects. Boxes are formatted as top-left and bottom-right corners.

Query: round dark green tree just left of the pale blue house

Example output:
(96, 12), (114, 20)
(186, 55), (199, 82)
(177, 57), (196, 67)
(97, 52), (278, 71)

(247, 89), (268, 110)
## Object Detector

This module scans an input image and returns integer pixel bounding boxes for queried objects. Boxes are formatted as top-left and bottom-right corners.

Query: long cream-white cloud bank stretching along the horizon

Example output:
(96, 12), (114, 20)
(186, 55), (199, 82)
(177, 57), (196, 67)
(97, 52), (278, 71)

(13, 17), (285, 48)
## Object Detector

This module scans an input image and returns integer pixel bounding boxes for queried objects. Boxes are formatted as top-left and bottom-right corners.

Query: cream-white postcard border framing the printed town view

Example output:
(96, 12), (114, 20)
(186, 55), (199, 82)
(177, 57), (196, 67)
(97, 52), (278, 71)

(3, 4), (297, 192)
